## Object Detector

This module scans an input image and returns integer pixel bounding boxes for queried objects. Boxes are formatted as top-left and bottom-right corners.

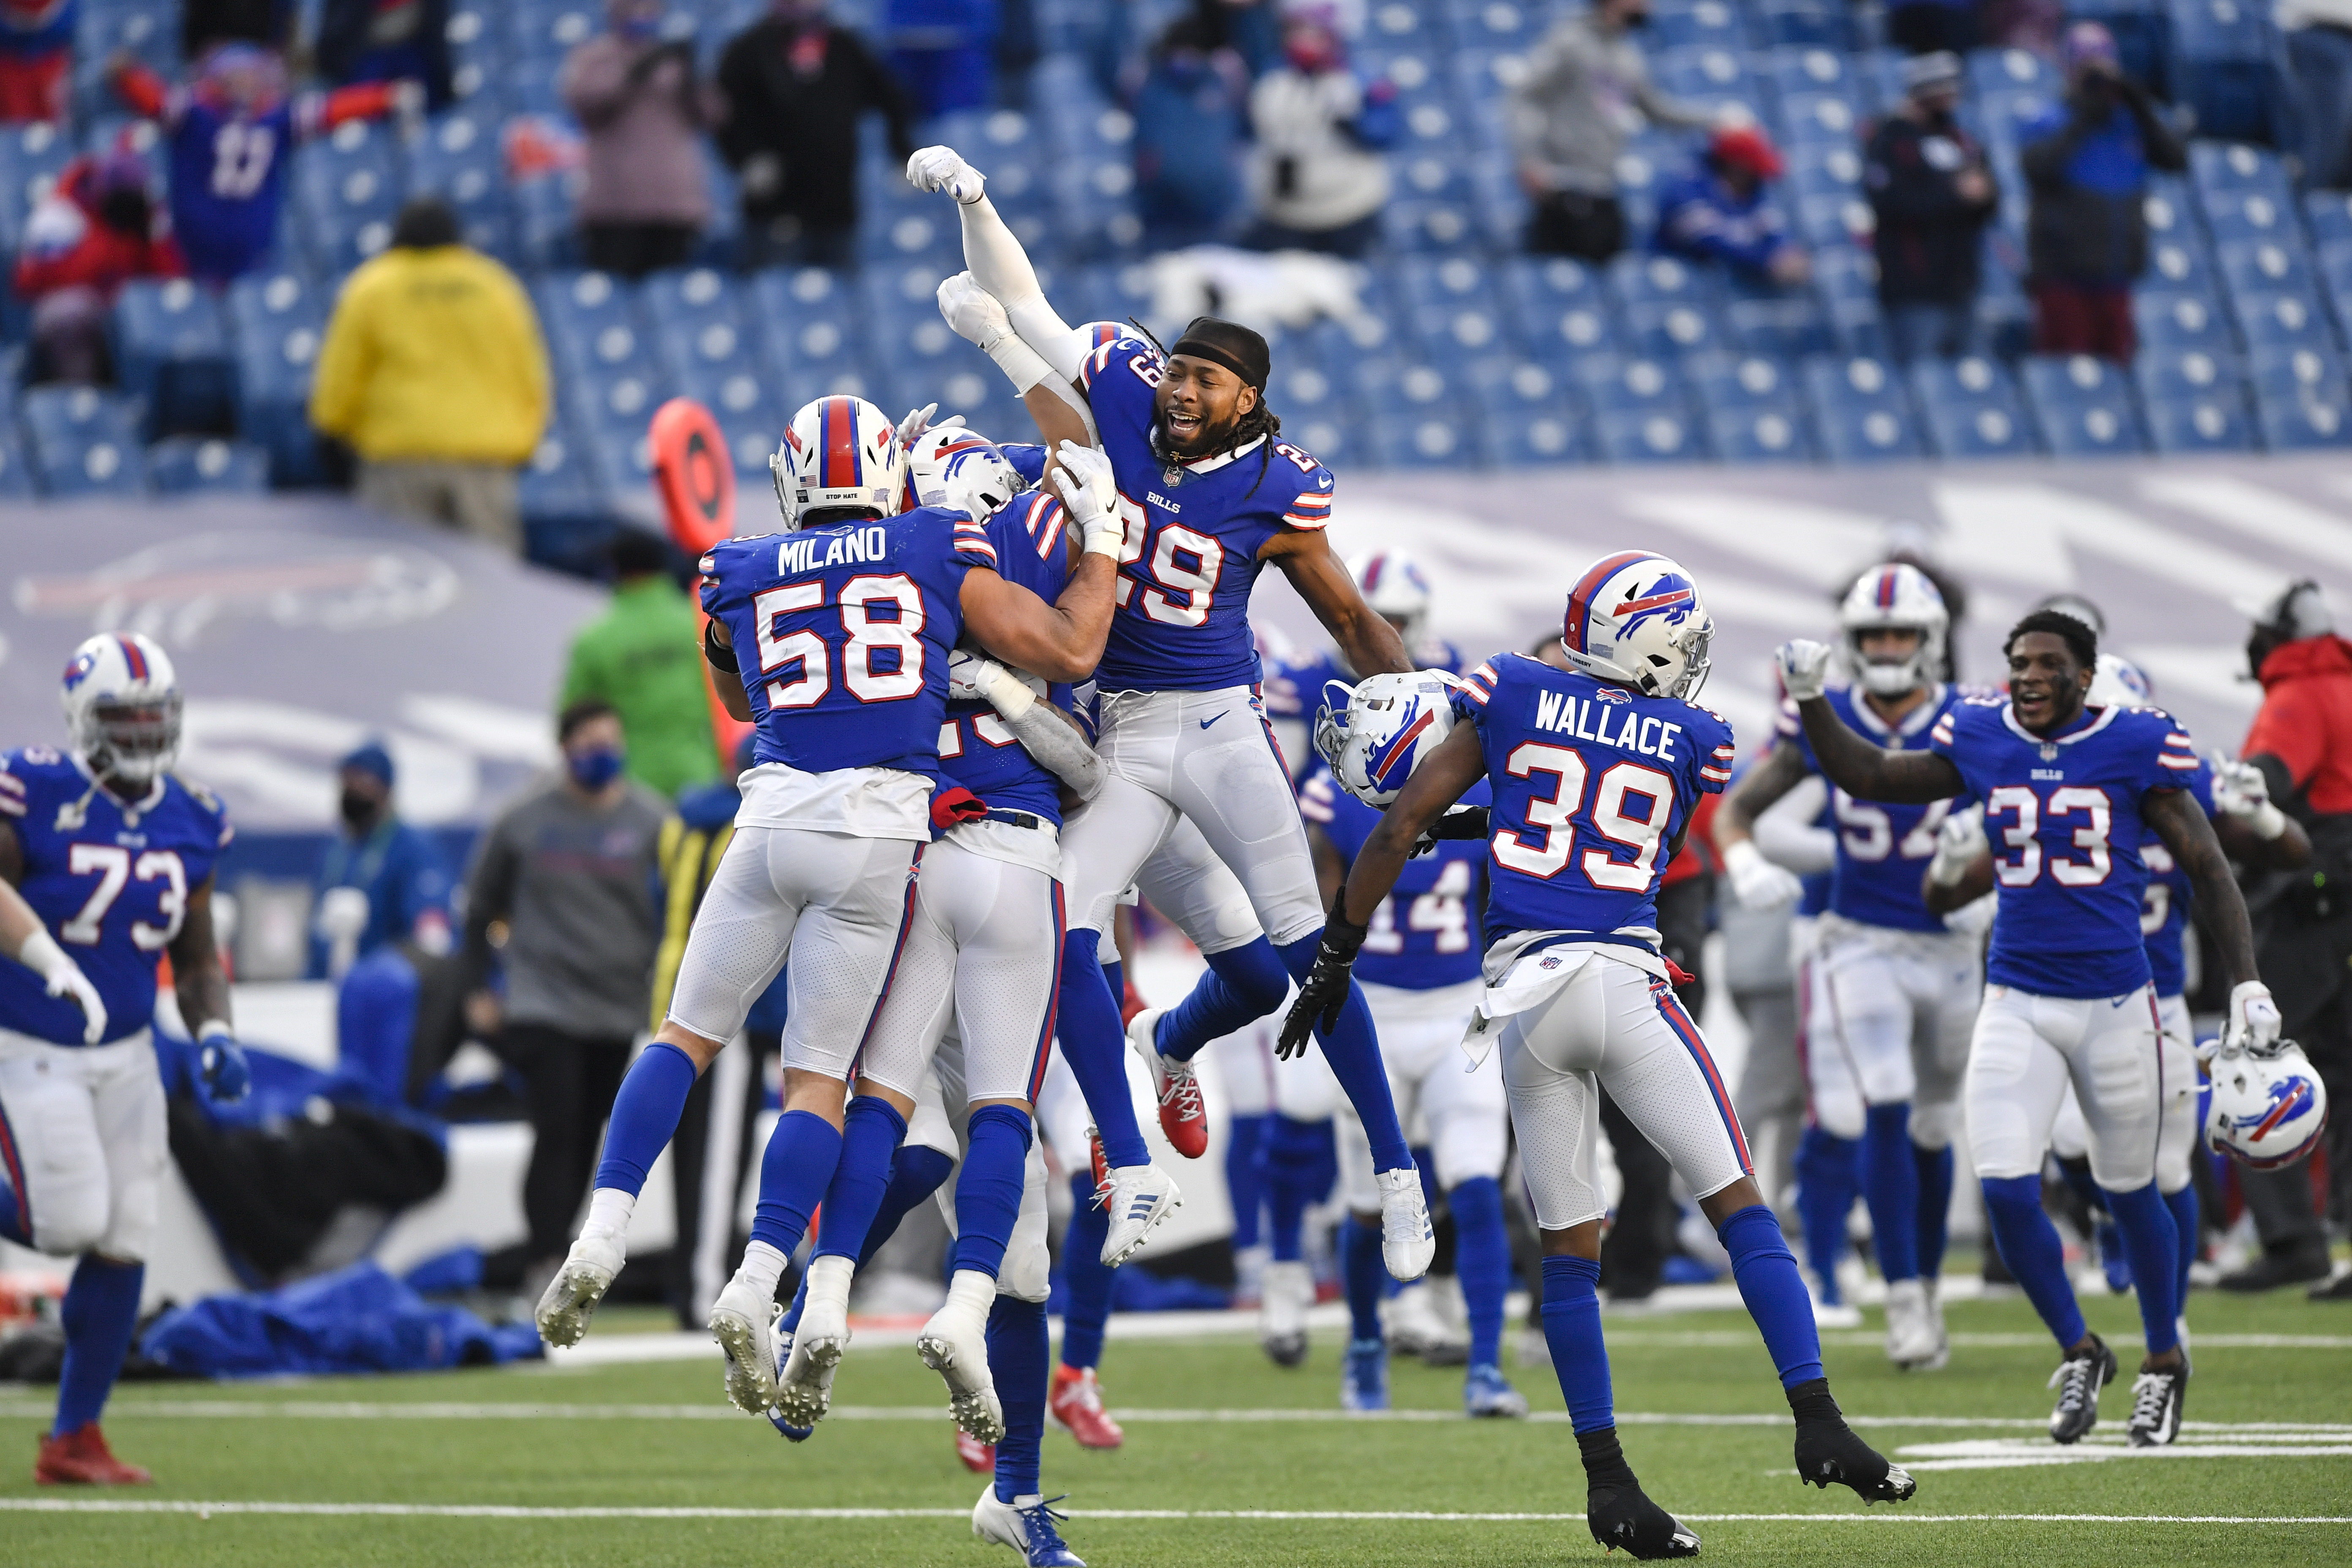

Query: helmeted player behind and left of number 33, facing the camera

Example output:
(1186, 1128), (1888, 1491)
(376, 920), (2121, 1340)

(1715, 562), (1983, 1371)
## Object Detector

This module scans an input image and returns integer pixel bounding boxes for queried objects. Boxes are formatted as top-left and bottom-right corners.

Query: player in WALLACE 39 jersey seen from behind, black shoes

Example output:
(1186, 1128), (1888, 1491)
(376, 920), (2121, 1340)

(1284, 550), (1914, 1559)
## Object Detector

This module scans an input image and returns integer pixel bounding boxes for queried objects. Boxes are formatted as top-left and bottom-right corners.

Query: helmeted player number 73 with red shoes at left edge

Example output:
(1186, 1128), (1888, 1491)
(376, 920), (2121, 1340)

(0, 632), (249, 1484)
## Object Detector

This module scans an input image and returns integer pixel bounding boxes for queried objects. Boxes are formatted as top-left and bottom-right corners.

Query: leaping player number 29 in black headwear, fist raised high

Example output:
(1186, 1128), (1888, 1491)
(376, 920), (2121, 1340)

(908, 148), (1435, 1279)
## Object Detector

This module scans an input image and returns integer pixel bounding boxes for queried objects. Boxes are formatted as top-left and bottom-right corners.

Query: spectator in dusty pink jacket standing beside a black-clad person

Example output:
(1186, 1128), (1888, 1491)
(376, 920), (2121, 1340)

(560, 0), (715, 278)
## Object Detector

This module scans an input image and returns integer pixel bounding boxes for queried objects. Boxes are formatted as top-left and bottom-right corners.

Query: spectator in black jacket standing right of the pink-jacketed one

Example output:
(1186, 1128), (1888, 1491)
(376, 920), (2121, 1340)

(720, 0), (915, 268)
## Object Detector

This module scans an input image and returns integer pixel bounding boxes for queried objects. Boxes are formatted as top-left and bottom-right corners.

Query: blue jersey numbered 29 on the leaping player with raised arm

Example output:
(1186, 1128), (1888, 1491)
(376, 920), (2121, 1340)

(1077, 336), (1334, 691)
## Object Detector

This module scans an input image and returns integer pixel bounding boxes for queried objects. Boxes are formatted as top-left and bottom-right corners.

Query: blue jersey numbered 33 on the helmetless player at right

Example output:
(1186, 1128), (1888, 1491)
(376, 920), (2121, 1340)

(1929, 696), (2199, 999)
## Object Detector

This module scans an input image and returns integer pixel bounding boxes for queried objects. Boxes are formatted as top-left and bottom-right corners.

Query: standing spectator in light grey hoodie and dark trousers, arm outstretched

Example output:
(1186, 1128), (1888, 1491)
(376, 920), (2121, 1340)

(1508, 0), (1710, 261)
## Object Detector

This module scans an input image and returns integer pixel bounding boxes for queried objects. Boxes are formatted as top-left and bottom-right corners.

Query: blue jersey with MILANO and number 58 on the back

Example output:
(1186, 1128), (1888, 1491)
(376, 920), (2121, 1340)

(701, 506), (997, 778)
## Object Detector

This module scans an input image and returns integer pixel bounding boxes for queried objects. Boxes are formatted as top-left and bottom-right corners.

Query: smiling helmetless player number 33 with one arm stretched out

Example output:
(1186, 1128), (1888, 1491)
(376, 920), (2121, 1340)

(1778, 609), (2279, 1446)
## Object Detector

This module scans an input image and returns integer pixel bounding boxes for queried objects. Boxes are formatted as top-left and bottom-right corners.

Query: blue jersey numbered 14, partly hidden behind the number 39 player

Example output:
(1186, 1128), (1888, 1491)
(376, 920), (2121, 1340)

(1298, 760), (1494, 990)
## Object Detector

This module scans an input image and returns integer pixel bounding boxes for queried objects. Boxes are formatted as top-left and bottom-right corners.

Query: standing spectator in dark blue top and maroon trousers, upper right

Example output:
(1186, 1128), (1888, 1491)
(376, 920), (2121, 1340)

(2018, 21), (2187, 362)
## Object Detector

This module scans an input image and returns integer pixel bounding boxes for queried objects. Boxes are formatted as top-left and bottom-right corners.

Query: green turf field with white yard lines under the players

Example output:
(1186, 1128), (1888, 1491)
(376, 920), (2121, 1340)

(0, 1290), (2352, 1568)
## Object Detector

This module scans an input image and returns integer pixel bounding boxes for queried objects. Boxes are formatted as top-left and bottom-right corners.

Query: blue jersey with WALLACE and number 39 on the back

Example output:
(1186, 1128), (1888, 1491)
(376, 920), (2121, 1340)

(1454, 653), (1736, 950)
